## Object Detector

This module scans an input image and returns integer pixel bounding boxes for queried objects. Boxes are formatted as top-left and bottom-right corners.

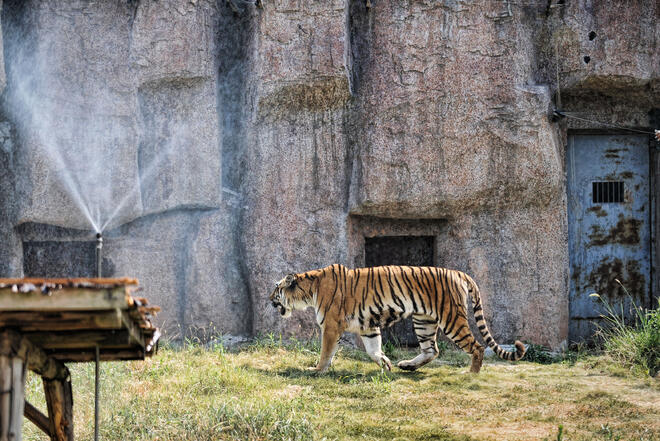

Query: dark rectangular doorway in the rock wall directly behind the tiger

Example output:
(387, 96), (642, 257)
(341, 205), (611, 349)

(364, 236), (435, 347)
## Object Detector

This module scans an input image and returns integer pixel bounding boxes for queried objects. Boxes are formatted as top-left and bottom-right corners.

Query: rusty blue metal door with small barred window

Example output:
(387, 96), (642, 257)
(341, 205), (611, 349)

(566, 135), (651, 342)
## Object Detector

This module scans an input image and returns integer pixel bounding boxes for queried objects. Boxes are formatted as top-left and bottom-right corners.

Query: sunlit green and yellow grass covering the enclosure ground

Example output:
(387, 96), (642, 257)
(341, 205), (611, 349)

(24, 336), (660, 441)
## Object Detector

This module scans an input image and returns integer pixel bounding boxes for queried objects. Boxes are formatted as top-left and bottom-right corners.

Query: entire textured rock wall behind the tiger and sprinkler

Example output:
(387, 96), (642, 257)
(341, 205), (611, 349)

(0, 0), (660, 347)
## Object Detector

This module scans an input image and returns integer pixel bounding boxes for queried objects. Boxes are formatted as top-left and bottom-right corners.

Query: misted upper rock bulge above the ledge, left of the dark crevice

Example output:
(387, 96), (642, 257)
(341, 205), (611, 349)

(3, 1), (221, 229)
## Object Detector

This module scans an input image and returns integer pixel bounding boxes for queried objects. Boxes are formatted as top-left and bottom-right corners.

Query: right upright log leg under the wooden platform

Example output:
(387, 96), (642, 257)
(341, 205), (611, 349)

(44, 379), (73, 441)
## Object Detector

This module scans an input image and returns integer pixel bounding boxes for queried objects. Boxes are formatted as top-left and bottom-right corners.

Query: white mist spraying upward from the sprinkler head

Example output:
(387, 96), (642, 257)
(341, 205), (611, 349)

(2, 2), (209, 232)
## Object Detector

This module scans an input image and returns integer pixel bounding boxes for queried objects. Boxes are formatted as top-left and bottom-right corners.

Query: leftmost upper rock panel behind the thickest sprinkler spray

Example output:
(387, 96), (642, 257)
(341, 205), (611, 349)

(3, 1), (140, 229)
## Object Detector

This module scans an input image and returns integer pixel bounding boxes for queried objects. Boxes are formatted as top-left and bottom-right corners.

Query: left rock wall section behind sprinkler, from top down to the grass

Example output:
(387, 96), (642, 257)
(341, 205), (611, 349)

(0, 0), (252, 336)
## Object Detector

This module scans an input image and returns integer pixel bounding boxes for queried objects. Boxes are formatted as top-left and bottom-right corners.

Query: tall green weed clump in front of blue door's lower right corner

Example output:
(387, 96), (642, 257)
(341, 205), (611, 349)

(591, 280), (660, 377)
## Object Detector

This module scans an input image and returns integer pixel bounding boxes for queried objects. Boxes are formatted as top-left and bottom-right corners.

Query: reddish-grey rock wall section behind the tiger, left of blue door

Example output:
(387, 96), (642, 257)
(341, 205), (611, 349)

(244, 2), (567, 346)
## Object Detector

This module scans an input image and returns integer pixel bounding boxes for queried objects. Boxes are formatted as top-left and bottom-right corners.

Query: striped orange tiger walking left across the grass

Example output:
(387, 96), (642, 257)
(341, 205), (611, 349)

(269, 264), (525, 373)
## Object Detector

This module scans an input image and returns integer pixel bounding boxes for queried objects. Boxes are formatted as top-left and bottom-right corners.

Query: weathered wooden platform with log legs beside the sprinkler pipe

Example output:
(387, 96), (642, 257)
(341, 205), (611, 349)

(0, 279), (160, 441)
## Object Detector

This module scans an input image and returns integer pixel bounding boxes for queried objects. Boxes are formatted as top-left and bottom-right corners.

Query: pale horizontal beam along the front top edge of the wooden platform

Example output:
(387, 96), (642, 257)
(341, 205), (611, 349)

(0, 286), (132, 311)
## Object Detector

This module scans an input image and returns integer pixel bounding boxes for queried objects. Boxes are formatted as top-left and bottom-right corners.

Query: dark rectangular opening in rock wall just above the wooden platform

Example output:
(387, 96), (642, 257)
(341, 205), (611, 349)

(23, 241), (96, 277)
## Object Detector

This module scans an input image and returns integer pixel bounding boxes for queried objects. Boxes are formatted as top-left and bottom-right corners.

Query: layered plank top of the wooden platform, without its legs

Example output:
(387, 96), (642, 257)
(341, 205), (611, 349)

(0, 278), (160, 362)
